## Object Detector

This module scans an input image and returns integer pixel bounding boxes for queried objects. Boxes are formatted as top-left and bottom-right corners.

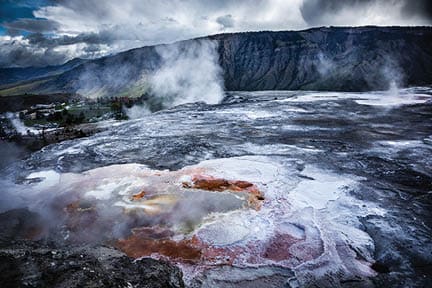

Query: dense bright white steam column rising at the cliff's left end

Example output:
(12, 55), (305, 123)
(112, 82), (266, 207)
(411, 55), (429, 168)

(150, 40), (223, 107)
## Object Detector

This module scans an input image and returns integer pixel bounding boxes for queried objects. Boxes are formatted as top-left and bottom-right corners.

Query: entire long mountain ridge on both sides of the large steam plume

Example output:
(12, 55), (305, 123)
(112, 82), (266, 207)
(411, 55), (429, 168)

(0, 26), (432, 96)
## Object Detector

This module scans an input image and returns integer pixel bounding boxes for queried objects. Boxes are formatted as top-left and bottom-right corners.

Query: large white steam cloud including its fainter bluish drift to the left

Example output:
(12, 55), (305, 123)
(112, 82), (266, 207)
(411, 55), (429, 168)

(77, 40), (224, 119)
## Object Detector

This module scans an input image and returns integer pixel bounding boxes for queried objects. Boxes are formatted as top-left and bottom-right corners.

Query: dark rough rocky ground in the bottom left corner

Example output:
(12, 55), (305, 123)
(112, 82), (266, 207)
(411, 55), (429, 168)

(0, 209), (184, 288)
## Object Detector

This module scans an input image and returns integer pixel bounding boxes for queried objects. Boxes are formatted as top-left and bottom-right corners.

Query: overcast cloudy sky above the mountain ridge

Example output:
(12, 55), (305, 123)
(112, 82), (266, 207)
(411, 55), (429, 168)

(0, 0), (432, 67)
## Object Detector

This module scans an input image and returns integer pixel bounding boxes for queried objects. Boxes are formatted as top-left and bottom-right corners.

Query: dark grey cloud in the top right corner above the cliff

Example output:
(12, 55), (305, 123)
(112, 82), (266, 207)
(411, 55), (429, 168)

(300, 0), (432, 26)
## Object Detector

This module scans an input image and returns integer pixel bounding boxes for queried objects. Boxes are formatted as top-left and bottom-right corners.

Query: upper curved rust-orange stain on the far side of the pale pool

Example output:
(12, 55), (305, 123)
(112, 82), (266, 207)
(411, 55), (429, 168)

(183, 175), (264, 210)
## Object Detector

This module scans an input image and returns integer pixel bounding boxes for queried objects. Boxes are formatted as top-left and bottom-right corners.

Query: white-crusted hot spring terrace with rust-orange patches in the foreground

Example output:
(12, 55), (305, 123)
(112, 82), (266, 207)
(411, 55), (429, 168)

(11, 156), (382, 280)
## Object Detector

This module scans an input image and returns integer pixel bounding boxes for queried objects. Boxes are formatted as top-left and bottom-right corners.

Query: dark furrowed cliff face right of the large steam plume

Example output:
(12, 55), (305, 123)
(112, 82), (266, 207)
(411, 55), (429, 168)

(210, 27), (432, 91)
